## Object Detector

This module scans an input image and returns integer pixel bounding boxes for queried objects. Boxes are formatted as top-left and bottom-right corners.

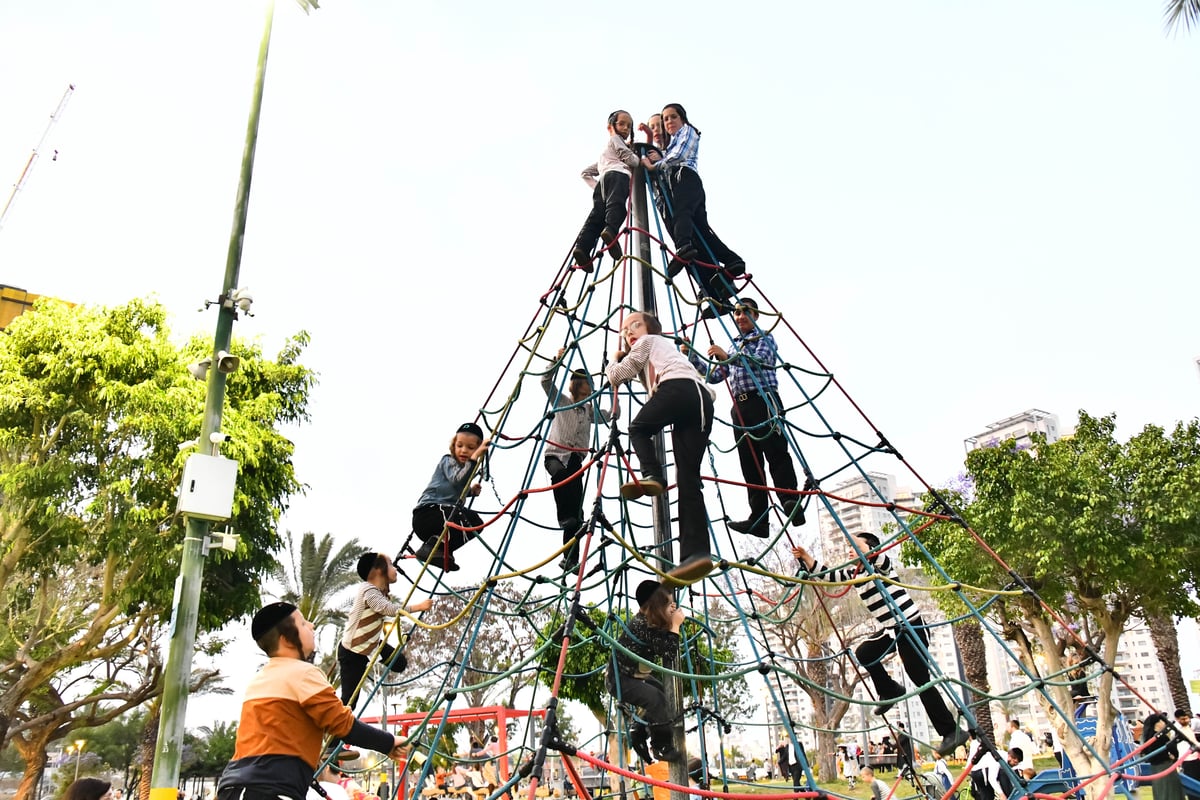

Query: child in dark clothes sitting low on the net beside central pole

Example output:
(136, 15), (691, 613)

(605, 581), (684, 762)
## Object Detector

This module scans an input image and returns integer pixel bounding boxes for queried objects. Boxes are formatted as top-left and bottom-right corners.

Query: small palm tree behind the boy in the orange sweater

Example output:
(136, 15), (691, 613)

(271, 531), (364, 631)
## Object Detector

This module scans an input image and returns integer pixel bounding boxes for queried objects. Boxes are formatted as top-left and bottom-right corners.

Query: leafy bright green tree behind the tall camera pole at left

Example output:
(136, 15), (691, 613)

(0, 300), (313, 796)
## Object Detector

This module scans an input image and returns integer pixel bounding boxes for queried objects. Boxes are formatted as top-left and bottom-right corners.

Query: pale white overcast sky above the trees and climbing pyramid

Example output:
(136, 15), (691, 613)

(0, 0), (1200, 734)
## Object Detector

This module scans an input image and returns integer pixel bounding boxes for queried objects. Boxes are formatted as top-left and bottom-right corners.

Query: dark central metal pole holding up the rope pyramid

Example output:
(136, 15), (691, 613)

(632, 143), (688, 800)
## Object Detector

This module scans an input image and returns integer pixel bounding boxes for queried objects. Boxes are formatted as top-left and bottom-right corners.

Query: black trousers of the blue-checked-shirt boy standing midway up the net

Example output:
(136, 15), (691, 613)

(733, 392), (800, 522)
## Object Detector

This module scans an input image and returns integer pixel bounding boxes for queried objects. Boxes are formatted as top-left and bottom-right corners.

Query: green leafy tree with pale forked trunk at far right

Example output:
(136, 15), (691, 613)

(920, 411), (1200, 770)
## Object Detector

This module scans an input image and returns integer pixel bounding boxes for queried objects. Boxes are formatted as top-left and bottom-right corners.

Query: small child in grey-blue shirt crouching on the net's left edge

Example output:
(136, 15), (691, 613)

(413, 422), (492, 572)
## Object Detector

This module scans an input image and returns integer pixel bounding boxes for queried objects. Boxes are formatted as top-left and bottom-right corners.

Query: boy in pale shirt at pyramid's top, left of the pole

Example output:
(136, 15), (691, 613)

(571, 109), (637, 272)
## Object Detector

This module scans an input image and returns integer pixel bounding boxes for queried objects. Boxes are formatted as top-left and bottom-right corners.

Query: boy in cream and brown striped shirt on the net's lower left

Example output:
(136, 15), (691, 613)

(337, 553), (433, 709)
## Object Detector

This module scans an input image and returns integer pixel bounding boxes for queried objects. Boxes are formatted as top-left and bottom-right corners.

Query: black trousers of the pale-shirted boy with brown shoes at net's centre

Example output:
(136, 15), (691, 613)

(629, 378), (713, 563)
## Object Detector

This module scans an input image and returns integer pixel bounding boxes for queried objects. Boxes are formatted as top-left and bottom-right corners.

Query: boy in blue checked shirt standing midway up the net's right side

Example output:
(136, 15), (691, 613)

(684, 297), (804, 539)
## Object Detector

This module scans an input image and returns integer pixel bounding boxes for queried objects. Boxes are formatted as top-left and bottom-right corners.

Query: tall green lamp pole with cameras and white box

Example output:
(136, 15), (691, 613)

(150, 0), (278, 800)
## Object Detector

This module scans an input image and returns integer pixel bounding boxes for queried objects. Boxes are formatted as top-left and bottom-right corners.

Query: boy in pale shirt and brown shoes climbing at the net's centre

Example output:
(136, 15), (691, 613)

(607, 312), (713, 579)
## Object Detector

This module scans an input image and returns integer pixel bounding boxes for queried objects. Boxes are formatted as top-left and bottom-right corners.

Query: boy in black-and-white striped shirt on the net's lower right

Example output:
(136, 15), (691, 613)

(792, 534), (967, 756)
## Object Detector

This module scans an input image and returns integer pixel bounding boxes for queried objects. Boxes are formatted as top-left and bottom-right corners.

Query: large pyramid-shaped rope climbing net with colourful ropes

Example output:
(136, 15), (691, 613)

(331, 125), (1180, 800)
